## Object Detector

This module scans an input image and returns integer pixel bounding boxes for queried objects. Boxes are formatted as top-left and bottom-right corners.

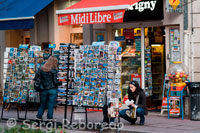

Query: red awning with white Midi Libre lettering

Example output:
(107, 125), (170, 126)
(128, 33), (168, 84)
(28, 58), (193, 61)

(56, 0), (140, 25)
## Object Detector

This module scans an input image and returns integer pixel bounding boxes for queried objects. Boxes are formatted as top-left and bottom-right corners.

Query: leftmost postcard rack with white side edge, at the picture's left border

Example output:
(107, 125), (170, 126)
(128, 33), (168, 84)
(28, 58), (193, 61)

(1, 48), (29, 120)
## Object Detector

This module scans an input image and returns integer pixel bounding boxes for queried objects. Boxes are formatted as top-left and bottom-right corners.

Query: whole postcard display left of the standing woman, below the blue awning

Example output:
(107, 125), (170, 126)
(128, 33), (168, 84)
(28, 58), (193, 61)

(1, 44), (41, 120)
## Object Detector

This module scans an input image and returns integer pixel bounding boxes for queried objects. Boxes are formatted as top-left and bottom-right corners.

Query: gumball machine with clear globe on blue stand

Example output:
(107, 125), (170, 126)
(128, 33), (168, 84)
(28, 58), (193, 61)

(167, 62), (188, 120)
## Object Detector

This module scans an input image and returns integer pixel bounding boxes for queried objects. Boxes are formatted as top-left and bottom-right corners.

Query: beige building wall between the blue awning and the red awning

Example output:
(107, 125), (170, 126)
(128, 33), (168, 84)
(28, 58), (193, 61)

(30, 0), (83, 49)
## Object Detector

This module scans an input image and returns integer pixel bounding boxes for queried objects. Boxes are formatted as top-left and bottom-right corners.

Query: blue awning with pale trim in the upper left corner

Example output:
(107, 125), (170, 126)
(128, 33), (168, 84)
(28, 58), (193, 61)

(0, 0), (53, 30)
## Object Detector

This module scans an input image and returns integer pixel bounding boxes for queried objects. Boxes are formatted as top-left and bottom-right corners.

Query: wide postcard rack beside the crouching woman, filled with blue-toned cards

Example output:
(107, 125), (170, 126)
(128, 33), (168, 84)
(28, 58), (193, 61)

(72, 42), (121, 107)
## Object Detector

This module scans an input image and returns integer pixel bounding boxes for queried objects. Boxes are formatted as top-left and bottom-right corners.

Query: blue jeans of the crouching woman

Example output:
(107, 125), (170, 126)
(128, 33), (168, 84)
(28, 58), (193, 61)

(119, 108), (145, 123)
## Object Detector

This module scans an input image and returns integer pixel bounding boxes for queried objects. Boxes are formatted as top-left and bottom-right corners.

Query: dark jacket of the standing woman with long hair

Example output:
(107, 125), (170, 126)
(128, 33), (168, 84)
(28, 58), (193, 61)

(40, 69), (62, 90)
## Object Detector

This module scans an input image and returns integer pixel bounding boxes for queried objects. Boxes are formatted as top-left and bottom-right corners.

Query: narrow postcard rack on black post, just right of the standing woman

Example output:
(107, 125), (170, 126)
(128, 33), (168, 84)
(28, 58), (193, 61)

(53, 43), (78, 105)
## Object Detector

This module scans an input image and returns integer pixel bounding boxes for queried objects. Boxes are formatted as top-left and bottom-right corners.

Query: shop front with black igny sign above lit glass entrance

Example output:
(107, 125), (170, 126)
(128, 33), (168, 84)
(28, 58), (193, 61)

(113, 1), (166, 109)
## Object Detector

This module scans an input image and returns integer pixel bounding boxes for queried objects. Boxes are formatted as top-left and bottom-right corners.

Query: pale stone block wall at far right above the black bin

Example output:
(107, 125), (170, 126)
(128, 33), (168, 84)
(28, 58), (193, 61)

(187, 0), (200, 82)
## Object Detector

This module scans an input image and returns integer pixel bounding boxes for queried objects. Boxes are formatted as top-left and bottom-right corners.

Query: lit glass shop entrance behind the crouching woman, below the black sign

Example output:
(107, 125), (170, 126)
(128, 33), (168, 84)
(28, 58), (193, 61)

(115, 26), (166, 110)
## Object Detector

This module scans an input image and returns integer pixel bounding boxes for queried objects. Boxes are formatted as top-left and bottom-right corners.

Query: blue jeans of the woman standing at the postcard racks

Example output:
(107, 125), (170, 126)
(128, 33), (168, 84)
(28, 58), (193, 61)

(36, 89), (58, 119)
